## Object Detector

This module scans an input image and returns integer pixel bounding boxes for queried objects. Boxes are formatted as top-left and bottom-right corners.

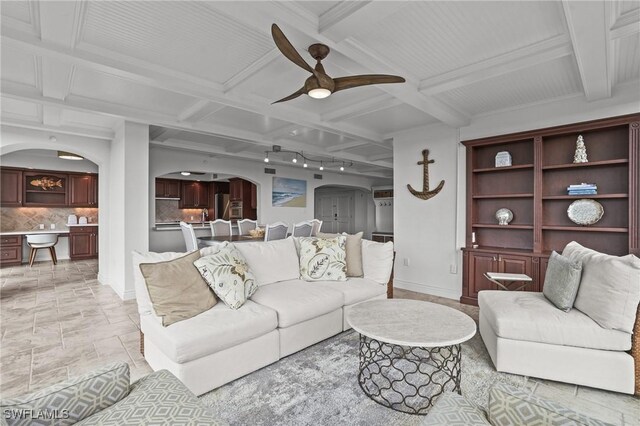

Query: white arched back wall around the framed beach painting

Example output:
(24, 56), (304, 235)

(148, 146), (390, 250)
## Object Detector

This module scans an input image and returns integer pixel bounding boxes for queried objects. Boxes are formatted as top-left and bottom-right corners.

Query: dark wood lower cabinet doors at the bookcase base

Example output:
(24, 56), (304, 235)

(462, 250), (539, 304)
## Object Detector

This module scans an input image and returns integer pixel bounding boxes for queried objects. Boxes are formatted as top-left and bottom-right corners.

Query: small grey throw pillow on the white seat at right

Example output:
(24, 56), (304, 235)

(542, 251), (582, 312)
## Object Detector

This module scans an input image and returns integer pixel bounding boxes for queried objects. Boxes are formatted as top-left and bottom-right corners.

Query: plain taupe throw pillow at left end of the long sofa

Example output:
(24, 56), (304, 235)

(140, 251), (217, 327)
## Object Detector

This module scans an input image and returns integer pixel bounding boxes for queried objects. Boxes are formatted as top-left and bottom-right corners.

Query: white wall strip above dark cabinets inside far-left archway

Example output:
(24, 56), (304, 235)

(0, 150), (98, 173)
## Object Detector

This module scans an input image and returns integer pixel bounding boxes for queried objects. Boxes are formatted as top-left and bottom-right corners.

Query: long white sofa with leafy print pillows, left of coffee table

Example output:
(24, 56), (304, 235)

(133, 238), (393, 395)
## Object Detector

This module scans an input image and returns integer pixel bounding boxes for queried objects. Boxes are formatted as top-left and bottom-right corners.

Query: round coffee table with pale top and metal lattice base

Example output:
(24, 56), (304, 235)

(347, 299), (476, 414)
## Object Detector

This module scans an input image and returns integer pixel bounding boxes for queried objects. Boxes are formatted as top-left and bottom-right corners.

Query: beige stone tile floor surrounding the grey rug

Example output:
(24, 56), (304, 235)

(0, 260), (640, 425)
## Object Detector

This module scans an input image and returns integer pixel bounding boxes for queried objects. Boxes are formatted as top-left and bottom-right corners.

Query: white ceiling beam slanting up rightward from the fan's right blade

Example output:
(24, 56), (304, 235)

(419, 35), (573, 96)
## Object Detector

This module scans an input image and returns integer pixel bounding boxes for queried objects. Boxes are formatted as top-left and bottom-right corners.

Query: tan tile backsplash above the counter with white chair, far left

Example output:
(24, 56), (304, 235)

(0, 207), (98, 232)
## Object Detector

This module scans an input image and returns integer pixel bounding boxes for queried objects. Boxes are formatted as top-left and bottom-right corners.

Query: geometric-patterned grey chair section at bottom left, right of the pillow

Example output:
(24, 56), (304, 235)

(73, 370), (220, 426)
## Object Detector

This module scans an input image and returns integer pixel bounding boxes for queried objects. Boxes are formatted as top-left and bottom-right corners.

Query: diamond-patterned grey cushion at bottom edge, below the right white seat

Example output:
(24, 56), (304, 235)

(487, 383), (608, 426)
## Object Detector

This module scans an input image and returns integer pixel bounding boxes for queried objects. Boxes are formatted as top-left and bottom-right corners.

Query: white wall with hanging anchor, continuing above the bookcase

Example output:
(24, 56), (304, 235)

(393, 86), (640, 299)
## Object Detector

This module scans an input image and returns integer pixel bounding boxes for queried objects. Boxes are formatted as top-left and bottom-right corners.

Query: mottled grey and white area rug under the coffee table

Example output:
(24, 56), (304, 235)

(200, 331), (525, 425)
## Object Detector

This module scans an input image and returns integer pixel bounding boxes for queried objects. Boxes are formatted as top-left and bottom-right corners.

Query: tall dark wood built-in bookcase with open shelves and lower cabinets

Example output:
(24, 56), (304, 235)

(460, 114), (640, 304)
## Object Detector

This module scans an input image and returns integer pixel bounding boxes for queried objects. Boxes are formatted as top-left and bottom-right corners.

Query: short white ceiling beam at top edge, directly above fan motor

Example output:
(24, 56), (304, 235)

(318, 1), (402, 43)
